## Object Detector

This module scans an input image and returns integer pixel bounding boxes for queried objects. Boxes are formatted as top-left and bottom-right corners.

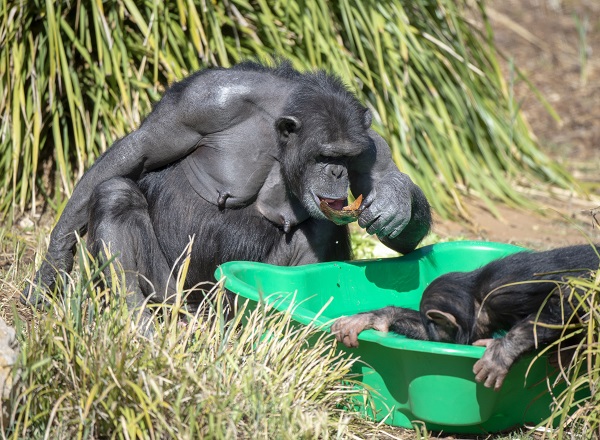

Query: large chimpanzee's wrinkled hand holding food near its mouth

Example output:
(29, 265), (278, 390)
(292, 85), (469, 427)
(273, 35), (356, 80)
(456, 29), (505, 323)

(358, 171), (414, 240)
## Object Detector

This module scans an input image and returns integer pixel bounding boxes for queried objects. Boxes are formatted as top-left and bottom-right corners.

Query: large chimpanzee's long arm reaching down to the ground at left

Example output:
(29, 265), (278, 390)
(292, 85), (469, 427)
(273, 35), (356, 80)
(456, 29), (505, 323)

(24, 70), (278, 299)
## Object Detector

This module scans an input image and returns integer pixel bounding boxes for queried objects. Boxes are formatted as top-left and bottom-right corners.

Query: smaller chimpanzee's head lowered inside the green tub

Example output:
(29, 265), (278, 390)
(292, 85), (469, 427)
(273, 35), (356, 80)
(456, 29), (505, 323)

(421, 272), (475, 344)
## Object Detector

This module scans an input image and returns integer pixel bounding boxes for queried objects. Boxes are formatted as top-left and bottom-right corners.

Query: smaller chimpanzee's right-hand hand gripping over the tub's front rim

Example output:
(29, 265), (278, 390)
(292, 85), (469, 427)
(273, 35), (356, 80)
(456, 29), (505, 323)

(473, 338), (514, 391)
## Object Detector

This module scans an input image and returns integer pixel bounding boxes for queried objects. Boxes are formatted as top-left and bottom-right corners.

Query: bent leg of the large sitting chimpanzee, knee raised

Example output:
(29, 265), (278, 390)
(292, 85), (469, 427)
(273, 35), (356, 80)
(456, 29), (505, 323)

(88, 177), (175, 316)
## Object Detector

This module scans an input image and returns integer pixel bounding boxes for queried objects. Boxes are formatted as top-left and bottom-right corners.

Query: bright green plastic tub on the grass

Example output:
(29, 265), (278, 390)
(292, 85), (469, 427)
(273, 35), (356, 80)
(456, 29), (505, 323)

(215, 241), (564, 433)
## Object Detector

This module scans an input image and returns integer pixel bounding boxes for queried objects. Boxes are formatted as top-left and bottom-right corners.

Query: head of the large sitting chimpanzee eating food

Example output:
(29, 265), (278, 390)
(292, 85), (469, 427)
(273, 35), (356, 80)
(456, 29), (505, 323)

(275, 73), (372, 223)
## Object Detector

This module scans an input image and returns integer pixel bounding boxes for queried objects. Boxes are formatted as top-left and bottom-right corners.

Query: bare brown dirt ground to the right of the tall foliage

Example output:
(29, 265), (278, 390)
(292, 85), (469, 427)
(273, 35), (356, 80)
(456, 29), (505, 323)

(434, 0), (600, 249)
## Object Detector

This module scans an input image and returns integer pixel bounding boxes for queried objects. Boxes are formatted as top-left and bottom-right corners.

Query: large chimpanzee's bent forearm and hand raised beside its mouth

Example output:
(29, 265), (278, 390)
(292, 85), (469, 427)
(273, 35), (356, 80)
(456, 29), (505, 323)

(350, 130), (431, 253)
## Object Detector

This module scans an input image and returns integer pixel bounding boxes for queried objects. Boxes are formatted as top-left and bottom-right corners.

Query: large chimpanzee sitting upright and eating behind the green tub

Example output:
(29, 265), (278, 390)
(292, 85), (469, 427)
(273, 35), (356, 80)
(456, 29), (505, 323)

(24, 62), (431, 316)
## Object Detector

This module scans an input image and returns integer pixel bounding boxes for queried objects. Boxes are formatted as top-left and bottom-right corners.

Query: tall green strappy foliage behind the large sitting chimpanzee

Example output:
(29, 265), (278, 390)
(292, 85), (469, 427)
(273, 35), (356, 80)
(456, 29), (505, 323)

(0, 0), (571, 217)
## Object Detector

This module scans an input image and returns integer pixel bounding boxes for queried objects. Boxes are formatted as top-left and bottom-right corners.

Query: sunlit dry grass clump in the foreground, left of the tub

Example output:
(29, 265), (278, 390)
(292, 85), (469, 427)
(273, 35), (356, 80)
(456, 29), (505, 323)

(3, 249), (357, 439)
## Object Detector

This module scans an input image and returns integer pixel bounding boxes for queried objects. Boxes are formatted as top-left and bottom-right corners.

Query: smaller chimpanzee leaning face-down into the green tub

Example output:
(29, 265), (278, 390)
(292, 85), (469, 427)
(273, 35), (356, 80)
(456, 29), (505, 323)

(331, 245), (600, 390)
